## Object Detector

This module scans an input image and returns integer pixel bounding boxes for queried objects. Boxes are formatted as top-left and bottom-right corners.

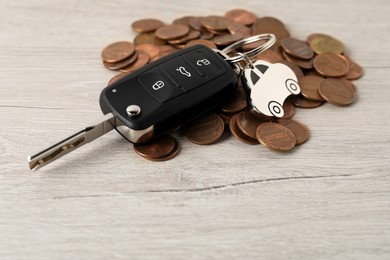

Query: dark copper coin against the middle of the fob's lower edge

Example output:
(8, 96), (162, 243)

(184, 113), (225, 145)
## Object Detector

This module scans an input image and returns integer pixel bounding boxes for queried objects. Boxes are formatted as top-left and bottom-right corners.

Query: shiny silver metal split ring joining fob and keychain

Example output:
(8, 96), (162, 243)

(221, 33), (276, 63)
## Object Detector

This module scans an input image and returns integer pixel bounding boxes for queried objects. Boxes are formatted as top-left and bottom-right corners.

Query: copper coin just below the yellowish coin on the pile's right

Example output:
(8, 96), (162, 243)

(313, 52), (349, 77)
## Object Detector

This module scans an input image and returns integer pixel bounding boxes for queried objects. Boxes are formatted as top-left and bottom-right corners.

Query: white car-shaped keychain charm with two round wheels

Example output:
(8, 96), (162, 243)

(242, 60), (301, 118)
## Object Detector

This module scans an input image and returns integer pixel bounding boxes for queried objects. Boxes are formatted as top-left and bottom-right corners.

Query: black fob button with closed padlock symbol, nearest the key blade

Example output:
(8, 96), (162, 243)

(138, 66), (184, 103)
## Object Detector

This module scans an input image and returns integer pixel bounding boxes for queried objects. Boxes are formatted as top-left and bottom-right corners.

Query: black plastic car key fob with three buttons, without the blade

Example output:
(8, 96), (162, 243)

(100, 45), (237, 143)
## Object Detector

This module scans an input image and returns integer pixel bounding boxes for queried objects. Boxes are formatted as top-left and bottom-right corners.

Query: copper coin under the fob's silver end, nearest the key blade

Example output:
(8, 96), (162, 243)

(134, 135), (176, 159)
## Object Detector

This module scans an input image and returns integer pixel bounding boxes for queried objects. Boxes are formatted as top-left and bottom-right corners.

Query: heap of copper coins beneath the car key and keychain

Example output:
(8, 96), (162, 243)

(102, 9), (363, 161)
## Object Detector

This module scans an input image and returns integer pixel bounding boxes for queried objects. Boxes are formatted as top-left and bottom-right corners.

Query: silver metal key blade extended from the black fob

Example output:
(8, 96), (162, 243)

(27, 113), (116, 171)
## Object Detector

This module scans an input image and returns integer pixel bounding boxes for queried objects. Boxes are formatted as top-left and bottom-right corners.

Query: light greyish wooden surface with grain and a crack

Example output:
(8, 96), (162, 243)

(0, 0), (390, 259)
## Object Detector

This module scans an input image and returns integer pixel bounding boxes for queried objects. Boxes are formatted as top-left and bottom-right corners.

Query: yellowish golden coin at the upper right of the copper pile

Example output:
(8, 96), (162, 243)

(307, 34), (345, 54)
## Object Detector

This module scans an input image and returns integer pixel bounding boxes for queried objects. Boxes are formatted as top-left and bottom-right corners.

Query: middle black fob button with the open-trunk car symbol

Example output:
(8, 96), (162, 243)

(160, 56), (207, 91)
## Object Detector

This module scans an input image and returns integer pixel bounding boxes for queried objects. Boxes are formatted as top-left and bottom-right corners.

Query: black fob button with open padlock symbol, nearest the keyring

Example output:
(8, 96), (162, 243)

(183, 50), (226, 80)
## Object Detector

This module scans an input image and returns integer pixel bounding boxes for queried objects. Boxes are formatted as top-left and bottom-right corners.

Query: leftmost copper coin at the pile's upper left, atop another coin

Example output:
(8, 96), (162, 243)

(102, 41), (135, 63)
